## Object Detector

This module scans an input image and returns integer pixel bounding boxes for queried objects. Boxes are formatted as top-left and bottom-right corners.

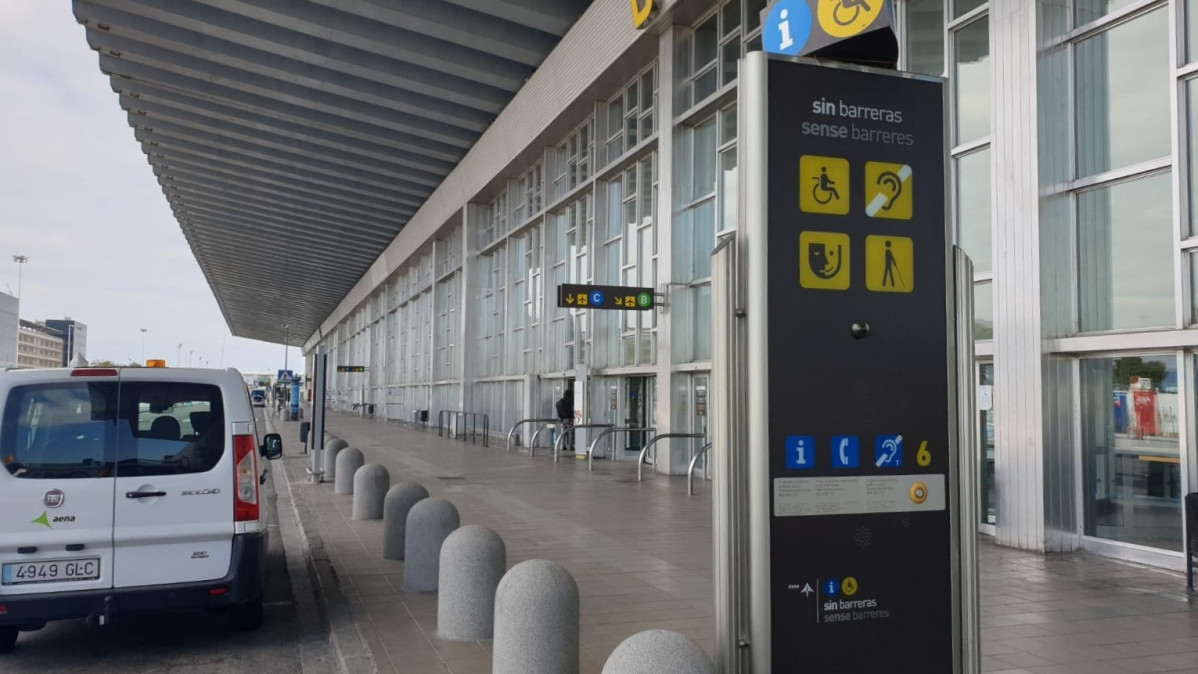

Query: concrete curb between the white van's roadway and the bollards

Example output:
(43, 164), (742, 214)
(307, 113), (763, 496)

(264, 413), (379, 674)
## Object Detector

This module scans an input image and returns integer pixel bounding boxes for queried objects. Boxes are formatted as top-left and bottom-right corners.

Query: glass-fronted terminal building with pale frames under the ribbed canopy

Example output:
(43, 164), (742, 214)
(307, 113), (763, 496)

(77, 0), (1198, 569)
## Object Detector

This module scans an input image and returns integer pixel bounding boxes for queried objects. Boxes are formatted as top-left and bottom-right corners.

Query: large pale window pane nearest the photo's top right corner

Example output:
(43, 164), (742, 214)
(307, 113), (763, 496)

(1073, 10), (1172, 177)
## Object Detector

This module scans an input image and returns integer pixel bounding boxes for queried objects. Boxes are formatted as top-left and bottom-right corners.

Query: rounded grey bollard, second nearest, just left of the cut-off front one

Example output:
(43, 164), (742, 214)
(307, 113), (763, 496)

(491, 559), (579, 674)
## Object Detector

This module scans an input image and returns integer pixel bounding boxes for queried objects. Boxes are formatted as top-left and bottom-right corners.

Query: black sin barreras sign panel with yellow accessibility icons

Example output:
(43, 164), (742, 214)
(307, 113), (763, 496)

(767, 60), (956, 673)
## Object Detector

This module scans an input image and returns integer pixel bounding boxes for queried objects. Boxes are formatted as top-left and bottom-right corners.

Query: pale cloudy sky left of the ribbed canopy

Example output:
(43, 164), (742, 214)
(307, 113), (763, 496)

(0, 0), (303, 374)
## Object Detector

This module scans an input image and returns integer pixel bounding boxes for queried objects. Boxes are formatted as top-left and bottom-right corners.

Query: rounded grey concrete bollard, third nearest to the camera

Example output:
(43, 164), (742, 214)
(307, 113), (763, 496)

(437, 524), (508, 642)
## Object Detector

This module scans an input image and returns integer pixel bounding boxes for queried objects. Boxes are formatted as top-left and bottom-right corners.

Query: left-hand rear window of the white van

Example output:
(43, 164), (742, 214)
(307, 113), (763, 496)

(0, 382), (116, 480)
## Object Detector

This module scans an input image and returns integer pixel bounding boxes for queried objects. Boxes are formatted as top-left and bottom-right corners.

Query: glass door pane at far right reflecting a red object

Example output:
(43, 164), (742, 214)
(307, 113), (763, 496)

(1081, 356), (1181, 551)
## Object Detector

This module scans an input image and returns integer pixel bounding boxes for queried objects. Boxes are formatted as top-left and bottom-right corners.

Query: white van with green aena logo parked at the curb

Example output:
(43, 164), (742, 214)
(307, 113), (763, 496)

(0, 368), (283, 652)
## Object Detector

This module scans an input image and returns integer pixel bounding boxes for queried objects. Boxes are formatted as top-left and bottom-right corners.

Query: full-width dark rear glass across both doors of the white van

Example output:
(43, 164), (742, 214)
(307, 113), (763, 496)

(0, 382), (225, 479)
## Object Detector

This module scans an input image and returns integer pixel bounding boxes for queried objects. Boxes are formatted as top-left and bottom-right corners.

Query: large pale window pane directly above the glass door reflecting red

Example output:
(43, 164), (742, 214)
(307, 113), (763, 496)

(1077, 174), (1174, 330)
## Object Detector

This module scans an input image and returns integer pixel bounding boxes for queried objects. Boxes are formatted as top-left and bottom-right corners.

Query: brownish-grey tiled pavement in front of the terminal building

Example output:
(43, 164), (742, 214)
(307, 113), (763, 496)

(276, 414), (1198, 674)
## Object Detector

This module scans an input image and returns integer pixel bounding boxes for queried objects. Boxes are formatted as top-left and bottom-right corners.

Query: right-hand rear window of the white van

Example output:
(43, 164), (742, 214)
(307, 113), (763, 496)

(116, 382), (225, 478)
